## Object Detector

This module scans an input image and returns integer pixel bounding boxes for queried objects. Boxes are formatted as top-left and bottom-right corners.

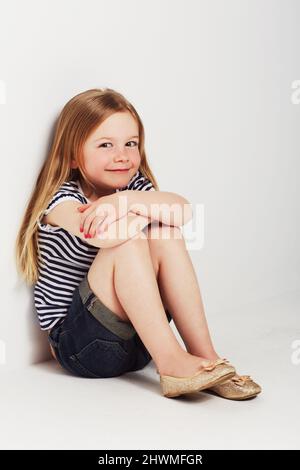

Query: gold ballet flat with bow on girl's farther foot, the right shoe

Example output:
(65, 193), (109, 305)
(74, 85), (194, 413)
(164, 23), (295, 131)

(205, 374), (262, 400)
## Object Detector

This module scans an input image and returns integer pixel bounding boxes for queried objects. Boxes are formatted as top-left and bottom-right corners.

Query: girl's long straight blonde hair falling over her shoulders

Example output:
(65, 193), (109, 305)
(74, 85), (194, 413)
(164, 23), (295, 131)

(15, 88), (158, 285)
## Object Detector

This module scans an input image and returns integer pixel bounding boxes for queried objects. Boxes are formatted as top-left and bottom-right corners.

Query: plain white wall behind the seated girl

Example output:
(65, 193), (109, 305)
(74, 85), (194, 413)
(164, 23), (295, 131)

(0, 0), (300, 370)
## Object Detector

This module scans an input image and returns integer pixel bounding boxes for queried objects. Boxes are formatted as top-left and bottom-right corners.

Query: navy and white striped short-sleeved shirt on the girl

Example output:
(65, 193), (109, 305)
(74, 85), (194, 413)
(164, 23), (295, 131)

(34, 170), (155, 330)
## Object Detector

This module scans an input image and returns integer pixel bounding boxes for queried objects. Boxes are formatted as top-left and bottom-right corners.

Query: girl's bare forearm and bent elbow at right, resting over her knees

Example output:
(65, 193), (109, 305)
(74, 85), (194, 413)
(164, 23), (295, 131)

(124, 190), (193, 226)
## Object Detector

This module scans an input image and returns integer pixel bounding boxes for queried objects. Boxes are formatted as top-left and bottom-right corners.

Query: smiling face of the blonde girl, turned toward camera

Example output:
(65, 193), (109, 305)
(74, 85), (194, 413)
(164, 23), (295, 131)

(72, 112), (141, 201)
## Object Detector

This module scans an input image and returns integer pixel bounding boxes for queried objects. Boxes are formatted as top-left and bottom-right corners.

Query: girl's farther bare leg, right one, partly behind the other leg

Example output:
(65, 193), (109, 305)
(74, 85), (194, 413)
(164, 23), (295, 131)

(147, 225), (219, 360)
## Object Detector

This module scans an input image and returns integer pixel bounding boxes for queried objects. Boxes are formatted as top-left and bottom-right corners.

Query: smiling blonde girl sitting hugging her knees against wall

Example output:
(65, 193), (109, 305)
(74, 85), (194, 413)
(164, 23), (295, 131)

(16, 88), (261, 399)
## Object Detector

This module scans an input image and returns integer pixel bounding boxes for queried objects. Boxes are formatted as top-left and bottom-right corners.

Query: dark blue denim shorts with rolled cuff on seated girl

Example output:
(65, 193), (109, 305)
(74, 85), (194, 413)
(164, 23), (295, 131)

(48, 274), (172, 378)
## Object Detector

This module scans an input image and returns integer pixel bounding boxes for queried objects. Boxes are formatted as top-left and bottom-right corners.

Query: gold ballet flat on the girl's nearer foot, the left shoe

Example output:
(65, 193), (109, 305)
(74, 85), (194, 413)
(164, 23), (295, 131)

(157, 358), (236, 398)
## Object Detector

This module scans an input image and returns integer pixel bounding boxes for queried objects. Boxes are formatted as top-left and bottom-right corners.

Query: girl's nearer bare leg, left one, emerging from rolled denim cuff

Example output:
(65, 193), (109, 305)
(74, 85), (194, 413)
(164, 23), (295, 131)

(88, 232), (210, 377)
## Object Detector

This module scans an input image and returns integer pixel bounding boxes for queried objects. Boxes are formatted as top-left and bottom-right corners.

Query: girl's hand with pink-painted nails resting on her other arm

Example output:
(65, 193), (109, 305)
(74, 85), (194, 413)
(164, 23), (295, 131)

(78, 191), (129, 238)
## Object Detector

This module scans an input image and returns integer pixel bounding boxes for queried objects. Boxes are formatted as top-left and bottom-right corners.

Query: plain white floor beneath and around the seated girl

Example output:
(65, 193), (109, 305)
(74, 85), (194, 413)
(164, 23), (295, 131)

(0, 292), (300, 450)
